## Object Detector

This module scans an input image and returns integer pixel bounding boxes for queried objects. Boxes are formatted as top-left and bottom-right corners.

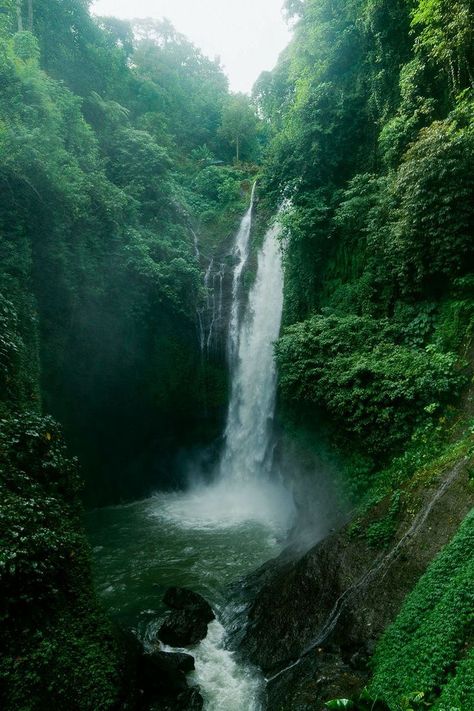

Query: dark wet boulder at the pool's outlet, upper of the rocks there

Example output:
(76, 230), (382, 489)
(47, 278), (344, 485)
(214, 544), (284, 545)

(158, 588), (215, 647)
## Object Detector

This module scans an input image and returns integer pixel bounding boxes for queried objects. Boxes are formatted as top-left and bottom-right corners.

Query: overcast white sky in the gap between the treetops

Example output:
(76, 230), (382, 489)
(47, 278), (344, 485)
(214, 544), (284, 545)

(92, 0), (290, 92)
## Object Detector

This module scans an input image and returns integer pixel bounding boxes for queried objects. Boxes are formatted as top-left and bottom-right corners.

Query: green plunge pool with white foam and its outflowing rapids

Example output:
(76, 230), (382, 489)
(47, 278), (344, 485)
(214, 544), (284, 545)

(86, 482), (292, 711)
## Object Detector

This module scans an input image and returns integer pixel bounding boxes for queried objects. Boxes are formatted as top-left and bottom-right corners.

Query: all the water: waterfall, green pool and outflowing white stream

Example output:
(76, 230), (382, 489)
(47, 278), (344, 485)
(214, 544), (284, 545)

(88, 196), (293, 711)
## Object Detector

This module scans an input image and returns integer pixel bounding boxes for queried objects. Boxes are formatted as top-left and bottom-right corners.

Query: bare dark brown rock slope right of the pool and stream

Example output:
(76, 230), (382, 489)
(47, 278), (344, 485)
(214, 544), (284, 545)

(240, 459), (474, 711)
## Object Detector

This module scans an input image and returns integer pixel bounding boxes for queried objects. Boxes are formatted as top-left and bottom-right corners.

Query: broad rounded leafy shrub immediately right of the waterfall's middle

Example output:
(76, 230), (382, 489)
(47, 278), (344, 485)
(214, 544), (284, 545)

(276, 316), (464, 453)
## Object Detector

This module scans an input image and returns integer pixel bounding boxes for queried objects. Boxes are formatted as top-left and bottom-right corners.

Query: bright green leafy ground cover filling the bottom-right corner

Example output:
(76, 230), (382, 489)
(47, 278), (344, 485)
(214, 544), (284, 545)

(369, 511), (474, 711)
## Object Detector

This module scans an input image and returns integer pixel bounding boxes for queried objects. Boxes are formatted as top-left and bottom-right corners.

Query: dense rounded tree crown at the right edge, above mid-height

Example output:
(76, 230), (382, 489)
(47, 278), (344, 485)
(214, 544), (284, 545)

(369, 104), (474, 294)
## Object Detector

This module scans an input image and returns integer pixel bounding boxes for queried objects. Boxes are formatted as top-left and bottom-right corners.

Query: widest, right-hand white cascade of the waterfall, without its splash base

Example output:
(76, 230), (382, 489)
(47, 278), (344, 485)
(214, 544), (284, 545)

(220, 223), (283, 482)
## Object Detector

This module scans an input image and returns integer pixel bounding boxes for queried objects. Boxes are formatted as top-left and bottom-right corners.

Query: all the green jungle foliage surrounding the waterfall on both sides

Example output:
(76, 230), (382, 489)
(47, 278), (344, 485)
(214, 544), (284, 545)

(0, 0), (474, 711)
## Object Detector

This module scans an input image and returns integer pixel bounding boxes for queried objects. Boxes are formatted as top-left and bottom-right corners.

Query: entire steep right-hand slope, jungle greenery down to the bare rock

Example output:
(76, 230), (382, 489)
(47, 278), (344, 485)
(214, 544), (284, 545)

(244, 0), (474, 711)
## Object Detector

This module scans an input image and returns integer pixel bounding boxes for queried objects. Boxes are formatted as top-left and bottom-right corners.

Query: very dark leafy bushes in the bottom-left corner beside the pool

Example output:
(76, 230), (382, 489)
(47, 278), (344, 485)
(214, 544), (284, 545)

(0, 413), (121, 711)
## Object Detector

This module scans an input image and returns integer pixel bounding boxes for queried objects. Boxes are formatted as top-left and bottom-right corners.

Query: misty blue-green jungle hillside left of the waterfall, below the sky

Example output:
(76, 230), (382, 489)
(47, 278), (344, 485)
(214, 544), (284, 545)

(0, 0), (262, 503)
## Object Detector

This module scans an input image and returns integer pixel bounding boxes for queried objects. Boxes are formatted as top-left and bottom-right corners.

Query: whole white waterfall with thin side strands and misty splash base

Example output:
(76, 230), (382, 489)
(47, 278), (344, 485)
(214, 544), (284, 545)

(168, 200), (295, 530)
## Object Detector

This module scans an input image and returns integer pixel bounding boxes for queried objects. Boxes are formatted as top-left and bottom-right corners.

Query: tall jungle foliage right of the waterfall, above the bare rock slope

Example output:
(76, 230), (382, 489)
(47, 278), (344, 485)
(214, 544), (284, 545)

(254, 0), (474, 498)
